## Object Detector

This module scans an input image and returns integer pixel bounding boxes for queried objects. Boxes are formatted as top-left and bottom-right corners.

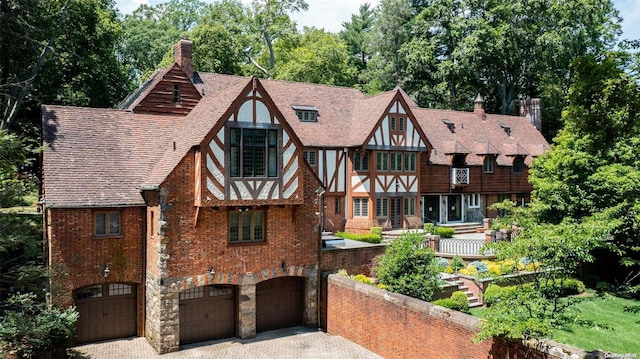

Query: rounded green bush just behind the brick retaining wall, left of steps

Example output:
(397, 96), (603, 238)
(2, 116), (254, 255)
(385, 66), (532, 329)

(375, 232), (440, 301)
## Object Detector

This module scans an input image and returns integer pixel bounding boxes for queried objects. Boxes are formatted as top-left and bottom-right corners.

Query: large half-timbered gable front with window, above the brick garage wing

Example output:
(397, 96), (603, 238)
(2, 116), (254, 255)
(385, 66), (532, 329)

(201, 79), (303, 206)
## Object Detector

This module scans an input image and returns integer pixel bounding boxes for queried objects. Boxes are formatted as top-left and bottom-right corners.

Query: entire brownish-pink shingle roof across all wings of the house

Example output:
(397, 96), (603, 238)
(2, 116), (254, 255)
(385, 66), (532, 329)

(43, 71), (548, 207)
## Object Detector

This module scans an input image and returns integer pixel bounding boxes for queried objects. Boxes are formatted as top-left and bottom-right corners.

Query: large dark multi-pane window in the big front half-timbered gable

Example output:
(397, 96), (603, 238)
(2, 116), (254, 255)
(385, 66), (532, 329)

(229, 128), (278, 177)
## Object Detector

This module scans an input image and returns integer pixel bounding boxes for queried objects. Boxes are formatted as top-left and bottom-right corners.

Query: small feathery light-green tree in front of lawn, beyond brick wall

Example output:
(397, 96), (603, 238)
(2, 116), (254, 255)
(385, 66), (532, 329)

(475, 201), (611, 341)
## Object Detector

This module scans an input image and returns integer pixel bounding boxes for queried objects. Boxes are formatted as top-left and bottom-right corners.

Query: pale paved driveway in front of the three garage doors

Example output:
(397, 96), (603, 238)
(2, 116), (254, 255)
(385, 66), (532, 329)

(69, 327), (384, 359)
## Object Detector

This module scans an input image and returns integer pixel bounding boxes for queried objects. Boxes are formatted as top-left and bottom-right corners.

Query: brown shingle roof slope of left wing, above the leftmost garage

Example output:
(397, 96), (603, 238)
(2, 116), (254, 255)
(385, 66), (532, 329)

(42, 106), (176, 207)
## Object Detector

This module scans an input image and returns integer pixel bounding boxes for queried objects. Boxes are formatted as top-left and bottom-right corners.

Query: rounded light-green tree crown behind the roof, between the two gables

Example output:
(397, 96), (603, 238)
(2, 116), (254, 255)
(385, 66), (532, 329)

(273, 27), (355, 86)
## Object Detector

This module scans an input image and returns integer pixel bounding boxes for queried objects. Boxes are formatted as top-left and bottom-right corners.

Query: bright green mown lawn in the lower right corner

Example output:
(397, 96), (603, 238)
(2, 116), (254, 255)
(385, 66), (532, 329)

(471, 296), (640, 356)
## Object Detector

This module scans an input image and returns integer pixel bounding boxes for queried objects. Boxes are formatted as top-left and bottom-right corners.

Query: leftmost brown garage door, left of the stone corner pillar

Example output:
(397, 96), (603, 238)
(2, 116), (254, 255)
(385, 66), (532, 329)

(75, 283), (138, 343)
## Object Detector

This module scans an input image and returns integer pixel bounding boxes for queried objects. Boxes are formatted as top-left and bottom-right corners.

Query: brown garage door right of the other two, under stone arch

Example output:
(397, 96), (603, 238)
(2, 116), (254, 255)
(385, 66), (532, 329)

(256, 277), (304, 332)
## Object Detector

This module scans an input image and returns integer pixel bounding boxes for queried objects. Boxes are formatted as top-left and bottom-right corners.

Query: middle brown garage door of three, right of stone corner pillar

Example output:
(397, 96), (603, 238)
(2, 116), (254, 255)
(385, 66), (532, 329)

(180, 285), (236, 344)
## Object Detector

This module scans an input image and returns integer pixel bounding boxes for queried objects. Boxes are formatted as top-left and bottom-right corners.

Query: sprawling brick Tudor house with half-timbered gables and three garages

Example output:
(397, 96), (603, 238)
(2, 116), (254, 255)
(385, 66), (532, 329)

(42, 40), (548, 353)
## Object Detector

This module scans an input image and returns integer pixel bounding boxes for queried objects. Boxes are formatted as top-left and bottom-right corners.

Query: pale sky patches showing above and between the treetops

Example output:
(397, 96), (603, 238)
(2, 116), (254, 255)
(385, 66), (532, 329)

(116, 0), (640, 40)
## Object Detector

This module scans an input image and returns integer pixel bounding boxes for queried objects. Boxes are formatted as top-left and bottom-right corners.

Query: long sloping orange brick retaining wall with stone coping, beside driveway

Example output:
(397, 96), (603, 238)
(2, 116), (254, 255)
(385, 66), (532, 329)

(327, 275), (587, 359)
